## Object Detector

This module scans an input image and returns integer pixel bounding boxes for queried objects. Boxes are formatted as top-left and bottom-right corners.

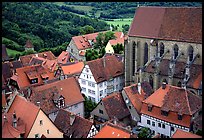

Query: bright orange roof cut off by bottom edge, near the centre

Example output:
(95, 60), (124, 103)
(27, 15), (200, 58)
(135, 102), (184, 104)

(94, 124), (130, 138)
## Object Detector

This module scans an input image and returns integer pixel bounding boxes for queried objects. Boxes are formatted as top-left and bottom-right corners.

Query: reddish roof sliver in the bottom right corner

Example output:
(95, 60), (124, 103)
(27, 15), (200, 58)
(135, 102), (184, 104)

(172, 129), (202, 138)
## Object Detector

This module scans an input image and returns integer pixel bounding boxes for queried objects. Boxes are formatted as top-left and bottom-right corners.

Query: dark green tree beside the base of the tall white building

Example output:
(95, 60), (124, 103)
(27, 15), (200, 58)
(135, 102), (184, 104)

(84, 96), (96, 119)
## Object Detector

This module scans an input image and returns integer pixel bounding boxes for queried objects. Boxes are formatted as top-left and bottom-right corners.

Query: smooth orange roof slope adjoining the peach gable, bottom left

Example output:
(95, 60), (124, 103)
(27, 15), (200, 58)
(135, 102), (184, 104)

(4, 95), (40, 138)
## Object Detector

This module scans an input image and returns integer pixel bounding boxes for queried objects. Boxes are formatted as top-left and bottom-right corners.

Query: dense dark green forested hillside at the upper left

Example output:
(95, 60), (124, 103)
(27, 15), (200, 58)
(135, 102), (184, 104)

(2, 2), (109, 51)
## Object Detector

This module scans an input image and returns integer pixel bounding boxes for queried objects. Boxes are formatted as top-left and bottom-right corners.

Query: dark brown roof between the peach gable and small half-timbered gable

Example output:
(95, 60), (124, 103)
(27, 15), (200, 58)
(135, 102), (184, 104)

(54, 109), (93, 138)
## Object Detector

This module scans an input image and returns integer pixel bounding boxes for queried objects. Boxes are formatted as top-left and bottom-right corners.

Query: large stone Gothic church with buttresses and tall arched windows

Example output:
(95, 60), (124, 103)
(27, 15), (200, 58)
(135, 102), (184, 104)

(125, 7), (202, 95)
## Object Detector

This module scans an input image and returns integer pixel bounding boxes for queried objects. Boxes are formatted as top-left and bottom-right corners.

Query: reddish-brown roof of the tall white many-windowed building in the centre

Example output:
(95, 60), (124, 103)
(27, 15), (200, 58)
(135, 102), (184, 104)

(87, 55), (124, 83)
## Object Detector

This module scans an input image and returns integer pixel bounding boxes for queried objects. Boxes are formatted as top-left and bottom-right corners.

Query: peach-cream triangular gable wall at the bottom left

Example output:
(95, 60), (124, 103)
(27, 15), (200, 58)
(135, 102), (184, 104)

(28, 110), (63, 138)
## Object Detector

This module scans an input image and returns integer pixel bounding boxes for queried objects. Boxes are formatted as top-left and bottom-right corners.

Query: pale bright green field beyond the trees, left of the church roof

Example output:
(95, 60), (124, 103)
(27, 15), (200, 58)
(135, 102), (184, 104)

(105, 18), (133, 31)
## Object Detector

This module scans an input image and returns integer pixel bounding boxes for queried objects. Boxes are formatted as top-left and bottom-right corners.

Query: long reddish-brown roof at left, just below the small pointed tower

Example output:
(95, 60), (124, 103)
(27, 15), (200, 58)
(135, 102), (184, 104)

(19, 51), (56, 66)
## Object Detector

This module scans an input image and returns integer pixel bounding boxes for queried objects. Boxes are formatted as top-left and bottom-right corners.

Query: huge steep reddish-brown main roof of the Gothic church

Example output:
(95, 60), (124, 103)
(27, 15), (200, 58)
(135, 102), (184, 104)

(128, 7), (202, 43)
